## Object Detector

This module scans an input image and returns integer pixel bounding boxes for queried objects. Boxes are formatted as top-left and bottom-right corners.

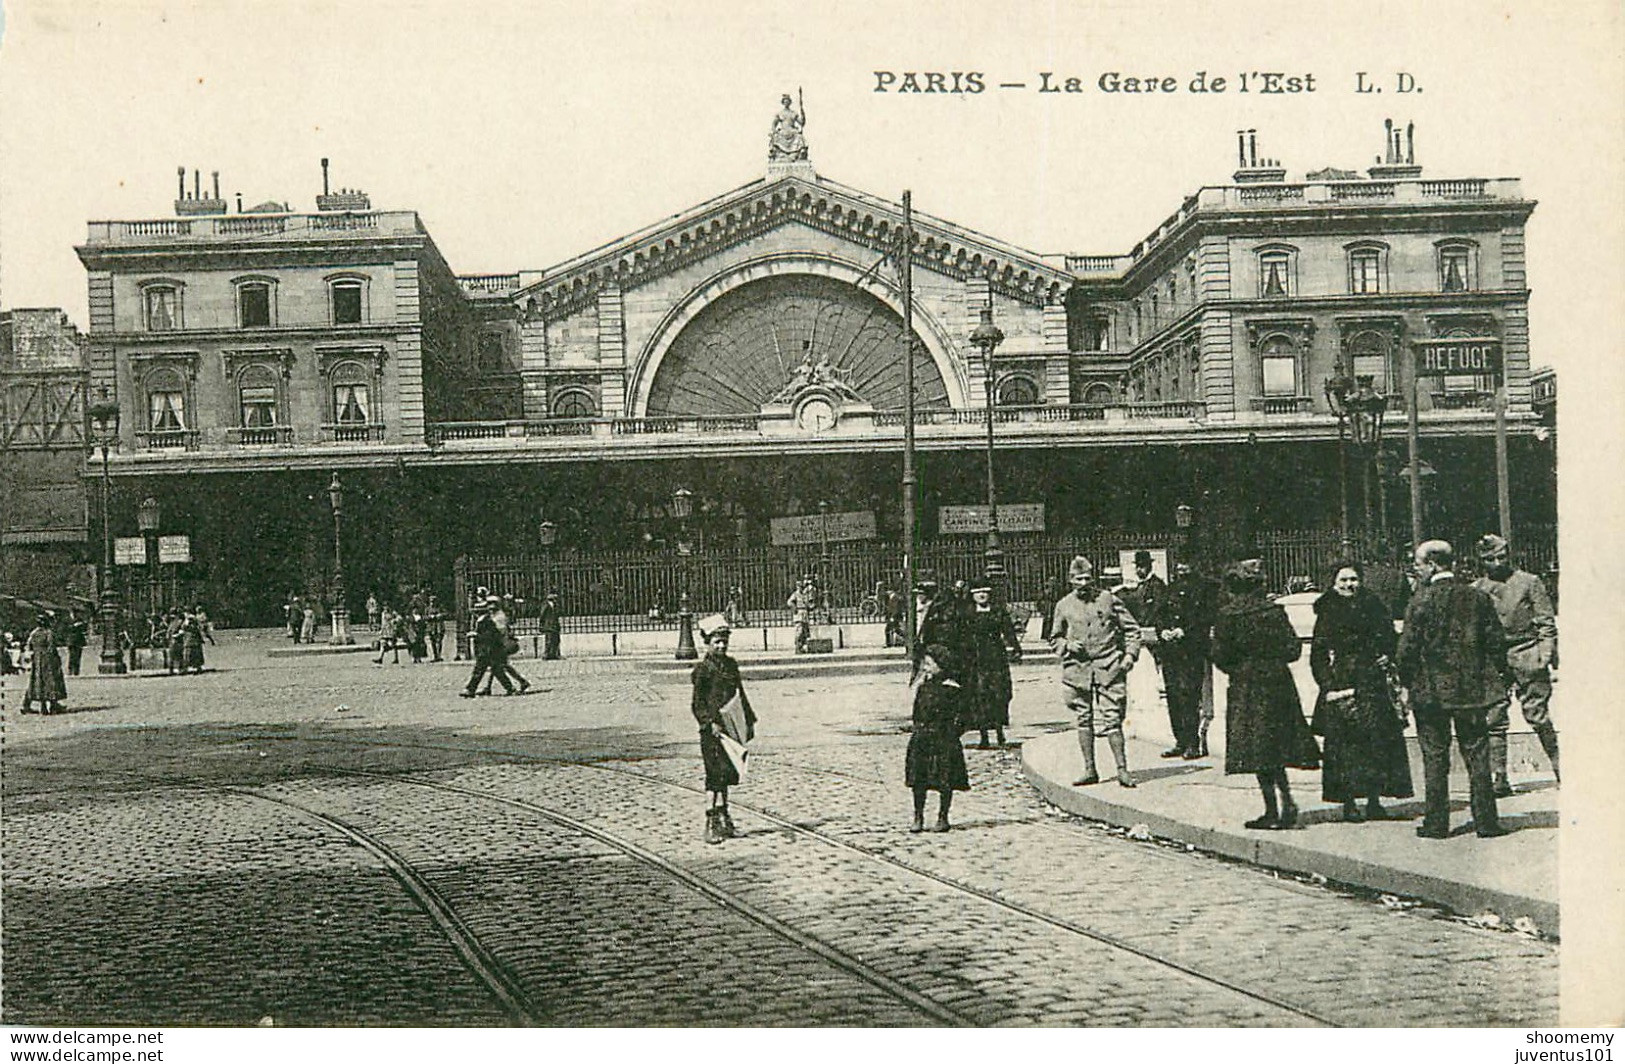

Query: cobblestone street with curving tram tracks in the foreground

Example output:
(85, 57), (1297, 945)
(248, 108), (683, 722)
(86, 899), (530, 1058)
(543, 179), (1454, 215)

(3, 638), (1558, 1027)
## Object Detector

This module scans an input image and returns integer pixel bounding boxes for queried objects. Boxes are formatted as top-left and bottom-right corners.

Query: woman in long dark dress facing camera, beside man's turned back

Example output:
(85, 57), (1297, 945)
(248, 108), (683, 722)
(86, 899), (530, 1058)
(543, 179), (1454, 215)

(1310, 562), (1415, 822)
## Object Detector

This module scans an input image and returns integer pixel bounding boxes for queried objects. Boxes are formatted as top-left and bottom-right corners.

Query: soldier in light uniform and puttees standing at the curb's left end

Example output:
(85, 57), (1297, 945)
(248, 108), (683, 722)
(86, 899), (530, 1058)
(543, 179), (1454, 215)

(1050, 554), (1141, 786)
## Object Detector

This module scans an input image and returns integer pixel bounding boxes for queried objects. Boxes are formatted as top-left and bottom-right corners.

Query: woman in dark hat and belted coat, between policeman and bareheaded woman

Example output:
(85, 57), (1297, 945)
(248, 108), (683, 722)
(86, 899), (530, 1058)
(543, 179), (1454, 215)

(1212, 559), (1320, 828)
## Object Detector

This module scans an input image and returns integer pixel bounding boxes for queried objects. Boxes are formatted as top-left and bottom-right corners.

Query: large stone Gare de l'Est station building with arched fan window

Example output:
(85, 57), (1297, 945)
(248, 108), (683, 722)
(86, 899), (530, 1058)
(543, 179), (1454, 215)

(76, 113), (1554, 619)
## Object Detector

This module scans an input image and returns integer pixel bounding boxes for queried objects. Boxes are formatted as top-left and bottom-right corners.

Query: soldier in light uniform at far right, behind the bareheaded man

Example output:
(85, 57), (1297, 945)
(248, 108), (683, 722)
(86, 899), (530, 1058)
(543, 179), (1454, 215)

(1472, 533), (1562, 798)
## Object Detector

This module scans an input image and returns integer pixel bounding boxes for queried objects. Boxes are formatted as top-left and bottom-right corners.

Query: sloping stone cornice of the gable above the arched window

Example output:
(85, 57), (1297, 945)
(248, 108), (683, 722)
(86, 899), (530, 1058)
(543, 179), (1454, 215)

(514, 174), (1073, 320)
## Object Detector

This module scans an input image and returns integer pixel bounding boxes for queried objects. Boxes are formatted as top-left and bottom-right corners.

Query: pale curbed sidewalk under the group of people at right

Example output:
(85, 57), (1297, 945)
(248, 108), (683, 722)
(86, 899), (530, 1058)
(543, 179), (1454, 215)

(1022, 737), (1558, 937)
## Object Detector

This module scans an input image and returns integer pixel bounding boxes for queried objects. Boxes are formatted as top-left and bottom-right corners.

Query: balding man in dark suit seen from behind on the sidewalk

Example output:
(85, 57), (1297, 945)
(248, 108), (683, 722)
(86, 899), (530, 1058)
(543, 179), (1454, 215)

(1394, 539), (1510, 838)
